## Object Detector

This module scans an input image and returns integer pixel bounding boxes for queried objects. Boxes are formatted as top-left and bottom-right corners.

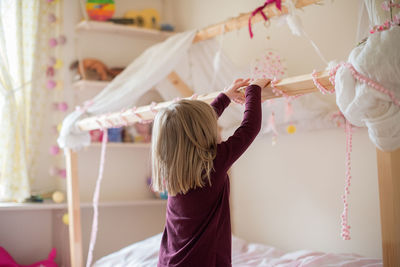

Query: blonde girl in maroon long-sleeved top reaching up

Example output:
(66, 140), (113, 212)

(152, 79), (270, 267)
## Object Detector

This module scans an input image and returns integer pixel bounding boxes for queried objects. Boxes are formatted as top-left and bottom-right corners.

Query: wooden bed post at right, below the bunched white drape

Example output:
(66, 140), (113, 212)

(376, 149), (400, 267)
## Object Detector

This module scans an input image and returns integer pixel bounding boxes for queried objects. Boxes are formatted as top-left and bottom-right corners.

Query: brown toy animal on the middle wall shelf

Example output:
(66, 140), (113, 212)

(70, 58), (124, 81)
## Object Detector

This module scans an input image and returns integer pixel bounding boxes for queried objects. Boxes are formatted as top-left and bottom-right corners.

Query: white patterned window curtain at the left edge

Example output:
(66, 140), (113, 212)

(0, 0), (48, 202)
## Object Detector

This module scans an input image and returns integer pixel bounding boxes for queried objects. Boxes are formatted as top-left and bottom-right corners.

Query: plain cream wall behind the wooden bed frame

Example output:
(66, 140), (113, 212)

(168, 0), (381, 257)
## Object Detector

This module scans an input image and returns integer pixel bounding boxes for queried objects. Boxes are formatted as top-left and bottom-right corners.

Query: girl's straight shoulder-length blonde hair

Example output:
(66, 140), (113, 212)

(152, 100), (218, 196)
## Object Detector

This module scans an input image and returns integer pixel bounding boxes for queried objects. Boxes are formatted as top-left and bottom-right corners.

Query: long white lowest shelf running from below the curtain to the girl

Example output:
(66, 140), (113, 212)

(0, 199), (167, 211)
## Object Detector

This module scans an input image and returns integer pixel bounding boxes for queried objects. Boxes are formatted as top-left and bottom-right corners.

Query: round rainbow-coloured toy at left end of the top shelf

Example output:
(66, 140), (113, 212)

(86, 0), (115, 21)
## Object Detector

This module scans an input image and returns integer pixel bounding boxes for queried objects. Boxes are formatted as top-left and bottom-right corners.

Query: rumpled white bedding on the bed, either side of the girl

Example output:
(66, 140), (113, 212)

(94, 234), (382, 267)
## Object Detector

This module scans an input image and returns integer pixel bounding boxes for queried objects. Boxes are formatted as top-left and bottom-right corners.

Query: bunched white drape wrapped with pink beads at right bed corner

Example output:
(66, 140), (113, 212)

(335, 0), (400, 151)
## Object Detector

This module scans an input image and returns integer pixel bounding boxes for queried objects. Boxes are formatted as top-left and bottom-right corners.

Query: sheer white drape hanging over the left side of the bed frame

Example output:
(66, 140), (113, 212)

(58, 31), (247, 149)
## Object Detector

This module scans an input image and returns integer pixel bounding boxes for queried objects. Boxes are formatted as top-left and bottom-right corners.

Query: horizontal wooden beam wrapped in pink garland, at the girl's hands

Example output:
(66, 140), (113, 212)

(77, 71), (332, 131)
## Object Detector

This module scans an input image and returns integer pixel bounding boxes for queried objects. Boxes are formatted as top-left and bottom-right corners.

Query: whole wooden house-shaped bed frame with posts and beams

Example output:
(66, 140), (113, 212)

(65, 0), (400, 267)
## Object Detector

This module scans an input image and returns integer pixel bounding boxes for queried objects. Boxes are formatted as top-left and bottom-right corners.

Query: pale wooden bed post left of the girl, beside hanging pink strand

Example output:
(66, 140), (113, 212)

(65, 148), (83, 267)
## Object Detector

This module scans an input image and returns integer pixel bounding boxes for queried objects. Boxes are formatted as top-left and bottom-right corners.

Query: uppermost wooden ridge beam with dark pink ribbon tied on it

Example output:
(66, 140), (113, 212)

(193, 0), (321, 43)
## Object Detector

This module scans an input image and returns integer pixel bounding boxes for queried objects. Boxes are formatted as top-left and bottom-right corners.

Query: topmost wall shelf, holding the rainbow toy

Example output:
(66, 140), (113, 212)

(75, 20), (175, 41)
